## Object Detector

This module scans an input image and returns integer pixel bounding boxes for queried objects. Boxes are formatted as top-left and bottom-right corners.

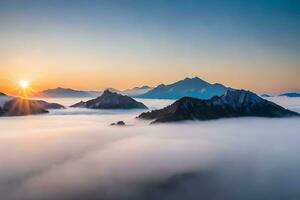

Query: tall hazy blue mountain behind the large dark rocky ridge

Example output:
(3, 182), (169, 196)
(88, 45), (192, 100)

(137, 77), (231, 99)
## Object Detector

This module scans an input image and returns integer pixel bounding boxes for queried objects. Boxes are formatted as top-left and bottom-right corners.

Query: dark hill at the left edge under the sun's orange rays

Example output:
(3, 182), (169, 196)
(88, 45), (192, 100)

(0, 98), (64, 116)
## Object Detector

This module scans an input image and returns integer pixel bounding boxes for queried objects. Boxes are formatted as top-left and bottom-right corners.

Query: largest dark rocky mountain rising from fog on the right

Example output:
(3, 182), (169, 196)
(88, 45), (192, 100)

(138, 90), (300, 123)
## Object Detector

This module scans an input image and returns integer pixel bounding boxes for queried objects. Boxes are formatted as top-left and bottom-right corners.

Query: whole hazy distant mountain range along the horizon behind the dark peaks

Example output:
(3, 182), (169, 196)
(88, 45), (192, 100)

(29, 77), (300, 99)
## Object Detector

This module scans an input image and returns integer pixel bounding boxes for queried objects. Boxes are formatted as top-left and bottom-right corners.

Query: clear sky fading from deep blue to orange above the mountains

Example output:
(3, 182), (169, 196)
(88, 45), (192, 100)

(0, 0), (300, 93)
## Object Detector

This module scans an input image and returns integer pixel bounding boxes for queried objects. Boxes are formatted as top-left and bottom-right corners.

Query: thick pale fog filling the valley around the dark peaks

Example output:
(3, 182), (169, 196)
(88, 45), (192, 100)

(0, 97), (300, 200)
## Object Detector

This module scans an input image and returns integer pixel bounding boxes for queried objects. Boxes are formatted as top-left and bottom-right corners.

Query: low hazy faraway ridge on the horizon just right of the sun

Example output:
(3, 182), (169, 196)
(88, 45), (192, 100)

(33, 87), (101, 97)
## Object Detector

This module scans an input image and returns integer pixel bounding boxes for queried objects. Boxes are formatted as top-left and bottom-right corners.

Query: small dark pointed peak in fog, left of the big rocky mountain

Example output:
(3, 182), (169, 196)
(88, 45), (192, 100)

(71, 90), (147, 109)
